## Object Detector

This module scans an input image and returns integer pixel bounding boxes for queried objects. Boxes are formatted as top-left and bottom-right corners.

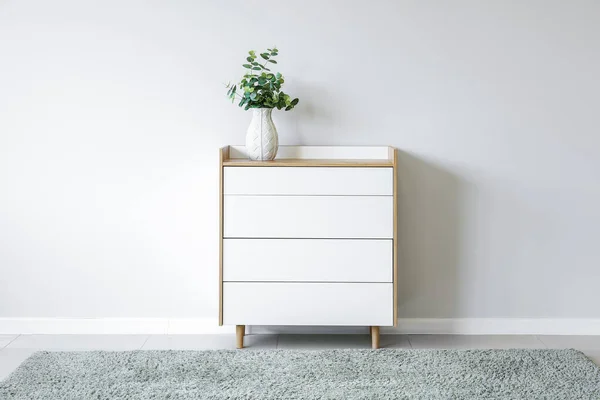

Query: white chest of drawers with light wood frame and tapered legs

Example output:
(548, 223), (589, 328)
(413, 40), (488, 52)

(219, 146), (398, 348)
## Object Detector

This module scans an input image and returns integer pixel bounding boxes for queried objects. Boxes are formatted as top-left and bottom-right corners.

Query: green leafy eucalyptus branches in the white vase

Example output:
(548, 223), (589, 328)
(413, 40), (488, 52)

(227, 47), (298, 111)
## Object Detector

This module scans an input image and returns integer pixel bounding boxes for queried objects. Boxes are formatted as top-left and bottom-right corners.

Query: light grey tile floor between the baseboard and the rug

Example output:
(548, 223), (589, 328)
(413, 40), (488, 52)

(0, 335), (600, 379)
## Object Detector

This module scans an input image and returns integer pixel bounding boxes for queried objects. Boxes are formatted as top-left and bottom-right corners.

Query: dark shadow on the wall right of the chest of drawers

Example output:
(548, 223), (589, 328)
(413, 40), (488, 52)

(398, 151), (463, 318)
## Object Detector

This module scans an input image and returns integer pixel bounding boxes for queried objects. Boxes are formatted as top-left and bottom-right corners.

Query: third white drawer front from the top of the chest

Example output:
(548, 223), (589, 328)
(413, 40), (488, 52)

(223, 239), (393, 282)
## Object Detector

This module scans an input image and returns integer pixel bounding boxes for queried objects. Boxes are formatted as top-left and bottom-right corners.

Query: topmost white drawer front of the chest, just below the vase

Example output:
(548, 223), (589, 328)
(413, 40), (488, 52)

(223, 167), (394, 196)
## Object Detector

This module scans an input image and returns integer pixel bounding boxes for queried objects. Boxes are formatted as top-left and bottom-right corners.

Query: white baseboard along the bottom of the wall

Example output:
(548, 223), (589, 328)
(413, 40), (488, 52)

(0, 318), (600, 335)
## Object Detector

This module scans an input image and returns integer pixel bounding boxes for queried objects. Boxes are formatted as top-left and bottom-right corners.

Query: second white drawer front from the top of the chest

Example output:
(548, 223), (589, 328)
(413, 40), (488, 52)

(223, 196), (394, 239)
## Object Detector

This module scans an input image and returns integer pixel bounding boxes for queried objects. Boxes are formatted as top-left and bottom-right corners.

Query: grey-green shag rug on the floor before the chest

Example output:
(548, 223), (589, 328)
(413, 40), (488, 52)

(0, 350), (600, 400)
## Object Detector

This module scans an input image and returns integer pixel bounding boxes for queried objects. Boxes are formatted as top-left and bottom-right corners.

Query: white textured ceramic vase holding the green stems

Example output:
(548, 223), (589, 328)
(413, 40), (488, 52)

(246, 108), (279, 161)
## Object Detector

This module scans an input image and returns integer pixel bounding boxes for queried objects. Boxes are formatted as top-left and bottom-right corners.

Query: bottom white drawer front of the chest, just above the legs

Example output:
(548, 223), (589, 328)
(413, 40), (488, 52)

(223, 282), (394, 326)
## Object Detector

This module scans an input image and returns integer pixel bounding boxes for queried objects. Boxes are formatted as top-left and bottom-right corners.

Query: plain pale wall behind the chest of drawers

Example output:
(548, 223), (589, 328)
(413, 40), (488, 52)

(0, 0), (600, 324)
